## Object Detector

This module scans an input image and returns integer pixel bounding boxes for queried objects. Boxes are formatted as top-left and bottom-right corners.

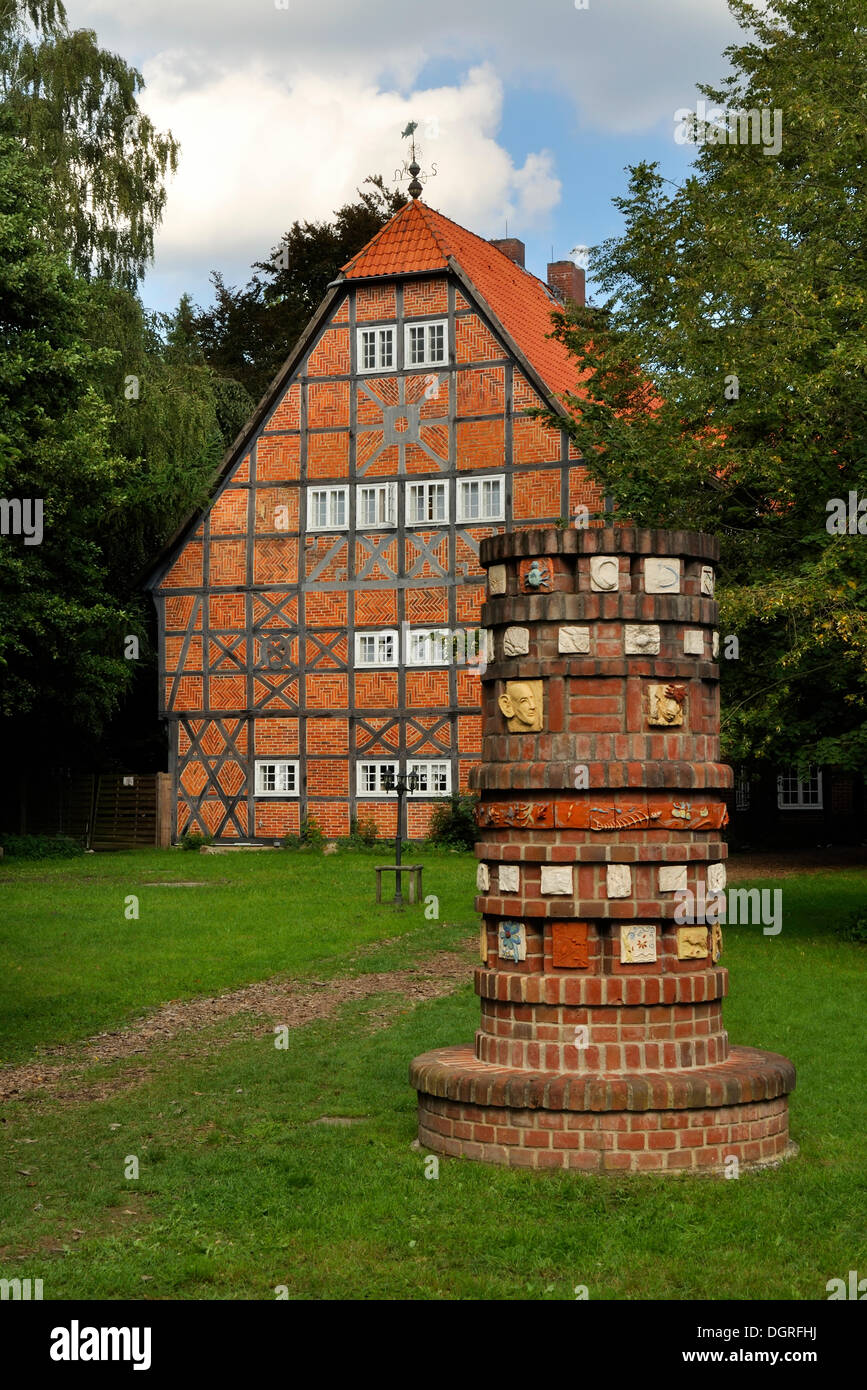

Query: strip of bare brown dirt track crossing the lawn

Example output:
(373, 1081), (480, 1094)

(0, 940), (478, 1104)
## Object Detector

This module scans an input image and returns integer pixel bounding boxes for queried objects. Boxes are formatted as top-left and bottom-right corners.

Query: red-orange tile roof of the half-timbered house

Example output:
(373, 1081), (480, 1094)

(342, 199), (578, 393)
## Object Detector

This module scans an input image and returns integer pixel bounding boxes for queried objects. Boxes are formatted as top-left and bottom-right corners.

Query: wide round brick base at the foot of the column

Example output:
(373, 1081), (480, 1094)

(410, 1047), (796, 1173)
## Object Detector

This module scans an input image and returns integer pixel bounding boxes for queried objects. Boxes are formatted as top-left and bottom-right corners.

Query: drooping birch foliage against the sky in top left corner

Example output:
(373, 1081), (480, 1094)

(0, 0), (178, 288)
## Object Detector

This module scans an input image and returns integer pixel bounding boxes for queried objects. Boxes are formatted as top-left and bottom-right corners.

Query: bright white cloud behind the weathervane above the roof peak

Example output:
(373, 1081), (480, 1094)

(142, 56), (560, 282)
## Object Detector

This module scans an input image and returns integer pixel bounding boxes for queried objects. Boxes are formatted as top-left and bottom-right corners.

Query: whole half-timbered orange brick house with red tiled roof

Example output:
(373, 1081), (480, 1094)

(149, 199), (599, 842)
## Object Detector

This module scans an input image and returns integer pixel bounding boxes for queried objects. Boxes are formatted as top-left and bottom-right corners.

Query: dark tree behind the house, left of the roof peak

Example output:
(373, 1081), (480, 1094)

(196, 174), (406, 400)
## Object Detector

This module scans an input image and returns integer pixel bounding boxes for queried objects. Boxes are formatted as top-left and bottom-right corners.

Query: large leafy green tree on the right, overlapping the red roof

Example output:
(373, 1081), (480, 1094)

(544, 0), (867, 769)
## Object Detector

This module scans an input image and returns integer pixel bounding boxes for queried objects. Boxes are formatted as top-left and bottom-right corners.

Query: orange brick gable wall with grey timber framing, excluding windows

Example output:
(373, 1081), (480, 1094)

(154, 274), (599, 841)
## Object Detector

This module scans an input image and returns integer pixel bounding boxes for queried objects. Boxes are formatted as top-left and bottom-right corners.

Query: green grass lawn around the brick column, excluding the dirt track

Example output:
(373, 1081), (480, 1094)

(0, 852), (867, 1300)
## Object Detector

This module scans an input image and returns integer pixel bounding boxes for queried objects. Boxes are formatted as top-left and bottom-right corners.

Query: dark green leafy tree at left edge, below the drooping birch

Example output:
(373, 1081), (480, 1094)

(0, 117), (136, 746)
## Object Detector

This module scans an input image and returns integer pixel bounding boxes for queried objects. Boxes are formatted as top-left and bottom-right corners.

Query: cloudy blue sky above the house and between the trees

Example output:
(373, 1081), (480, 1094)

(67, 0), (738, 309)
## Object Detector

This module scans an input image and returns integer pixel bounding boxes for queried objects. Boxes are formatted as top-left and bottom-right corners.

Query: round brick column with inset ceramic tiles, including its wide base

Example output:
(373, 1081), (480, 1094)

(410, 527), (795, 1173)
